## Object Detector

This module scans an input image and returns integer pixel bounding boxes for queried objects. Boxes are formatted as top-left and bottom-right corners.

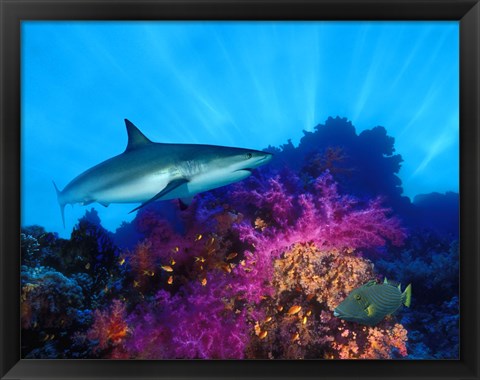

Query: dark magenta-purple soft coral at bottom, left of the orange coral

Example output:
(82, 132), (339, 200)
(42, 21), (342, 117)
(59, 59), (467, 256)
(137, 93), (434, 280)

(126, 274), (250, 359)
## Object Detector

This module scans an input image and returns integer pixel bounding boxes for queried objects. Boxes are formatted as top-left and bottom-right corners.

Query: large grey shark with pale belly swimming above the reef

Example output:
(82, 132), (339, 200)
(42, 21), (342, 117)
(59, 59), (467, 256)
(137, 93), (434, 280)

(53, 119), (272, 226)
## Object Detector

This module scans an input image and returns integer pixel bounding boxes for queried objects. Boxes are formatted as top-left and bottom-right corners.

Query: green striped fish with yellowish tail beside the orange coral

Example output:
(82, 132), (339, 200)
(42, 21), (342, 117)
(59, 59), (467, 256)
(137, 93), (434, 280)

(333, 278), (412, 326)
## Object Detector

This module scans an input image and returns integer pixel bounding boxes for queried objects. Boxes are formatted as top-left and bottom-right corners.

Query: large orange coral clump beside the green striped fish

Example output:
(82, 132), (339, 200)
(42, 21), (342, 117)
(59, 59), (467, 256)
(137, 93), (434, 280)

(248, 243), (407, 359)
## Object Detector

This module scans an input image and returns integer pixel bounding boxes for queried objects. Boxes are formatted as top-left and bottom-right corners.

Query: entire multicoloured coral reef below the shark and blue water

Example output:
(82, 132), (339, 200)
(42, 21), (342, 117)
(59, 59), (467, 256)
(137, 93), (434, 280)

(21, 118), (458, 359)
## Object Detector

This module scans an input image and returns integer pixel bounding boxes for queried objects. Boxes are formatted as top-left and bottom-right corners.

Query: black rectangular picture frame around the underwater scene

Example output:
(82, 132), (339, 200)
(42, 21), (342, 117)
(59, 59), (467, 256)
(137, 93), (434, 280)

(0, 0), (480, 379)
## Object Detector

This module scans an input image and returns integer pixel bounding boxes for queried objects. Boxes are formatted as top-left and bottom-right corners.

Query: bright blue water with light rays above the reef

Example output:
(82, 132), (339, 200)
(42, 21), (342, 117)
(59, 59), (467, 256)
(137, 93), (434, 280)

(22, 21), (459, 237)
